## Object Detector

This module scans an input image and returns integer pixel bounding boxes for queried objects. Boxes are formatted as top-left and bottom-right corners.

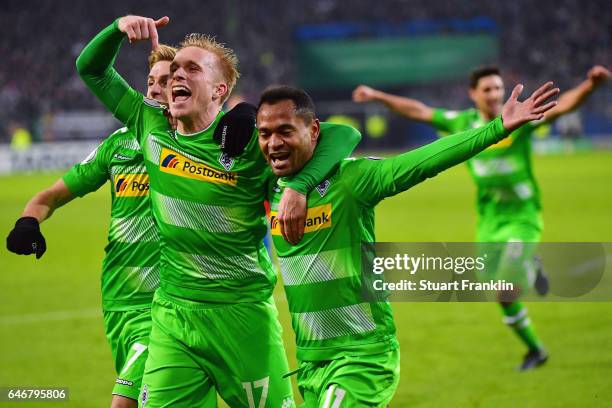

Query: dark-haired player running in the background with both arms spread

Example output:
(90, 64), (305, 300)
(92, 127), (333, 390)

(353, 66), (610, 370)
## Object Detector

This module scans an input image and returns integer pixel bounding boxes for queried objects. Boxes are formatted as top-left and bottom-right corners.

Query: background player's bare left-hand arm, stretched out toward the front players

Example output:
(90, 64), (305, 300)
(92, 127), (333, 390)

(353, 85), (433, 123)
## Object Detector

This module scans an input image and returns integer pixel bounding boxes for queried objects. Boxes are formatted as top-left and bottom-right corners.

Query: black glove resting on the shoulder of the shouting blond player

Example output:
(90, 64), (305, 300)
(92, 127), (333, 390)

(213, 102), (257, 157)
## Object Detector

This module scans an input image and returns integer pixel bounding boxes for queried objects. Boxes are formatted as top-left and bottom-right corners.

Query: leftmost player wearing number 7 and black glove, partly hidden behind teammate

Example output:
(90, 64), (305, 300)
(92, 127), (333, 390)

(7, 45), (177, 408)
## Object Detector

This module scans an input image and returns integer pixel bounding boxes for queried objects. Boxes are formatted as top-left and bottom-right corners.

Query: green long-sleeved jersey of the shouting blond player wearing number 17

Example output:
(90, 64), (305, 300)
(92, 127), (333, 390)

(77, 21), (359, 303)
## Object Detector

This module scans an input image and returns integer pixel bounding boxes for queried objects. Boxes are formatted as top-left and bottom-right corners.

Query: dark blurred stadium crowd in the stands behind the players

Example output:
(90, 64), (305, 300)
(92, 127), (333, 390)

(0, 0), (612, 142)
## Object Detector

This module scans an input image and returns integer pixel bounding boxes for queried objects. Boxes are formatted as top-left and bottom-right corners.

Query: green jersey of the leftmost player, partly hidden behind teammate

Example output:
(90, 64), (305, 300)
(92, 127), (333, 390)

(63, 128), (160, 311)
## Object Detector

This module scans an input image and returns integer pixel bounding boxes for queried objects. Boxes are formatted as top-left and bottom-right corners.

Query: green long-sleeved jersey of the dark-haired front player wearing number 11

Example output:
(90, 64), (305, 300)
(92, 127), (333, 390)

(269, 119), (507, 361)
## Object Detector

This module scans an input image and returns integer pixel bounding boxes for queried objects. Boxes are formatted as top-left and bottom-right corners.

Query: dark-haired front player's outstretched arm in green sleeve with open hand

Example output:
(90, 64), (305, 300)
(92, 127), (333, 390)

(347, 82), (559, 205)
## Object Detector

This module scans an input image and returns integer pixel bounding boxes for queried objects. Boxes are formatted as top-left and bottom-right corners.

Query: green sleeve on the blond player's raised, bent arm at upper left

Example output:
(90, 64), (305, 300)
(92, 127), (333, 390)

(76, 19), (167, 142)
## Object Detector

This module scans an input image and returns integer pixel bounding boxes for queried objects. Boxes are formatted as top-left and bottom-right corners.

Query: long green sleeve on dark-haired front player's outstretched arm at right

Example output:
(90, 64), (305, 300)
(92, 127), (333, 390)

(342, 118), (509, 206)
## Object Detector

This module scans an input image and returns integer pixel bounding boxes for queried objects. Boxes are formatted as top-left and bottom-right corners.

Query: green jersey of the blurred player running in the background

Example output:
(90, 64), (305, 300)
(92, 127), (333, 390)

(432, 109), (541, 219)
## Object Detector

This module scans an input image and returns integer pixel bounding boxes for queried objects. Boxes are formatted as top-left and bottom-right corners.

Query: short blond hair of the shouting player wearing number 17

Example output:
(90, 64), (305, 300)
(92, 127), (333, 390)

(179, 33), (240, 103)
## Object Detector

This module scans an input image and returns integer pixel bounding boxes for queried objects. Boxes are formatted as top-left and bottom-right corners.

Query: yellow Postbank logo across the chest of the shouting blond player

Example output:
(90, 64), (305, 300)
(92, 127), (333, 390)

(159, 147), (238, 186)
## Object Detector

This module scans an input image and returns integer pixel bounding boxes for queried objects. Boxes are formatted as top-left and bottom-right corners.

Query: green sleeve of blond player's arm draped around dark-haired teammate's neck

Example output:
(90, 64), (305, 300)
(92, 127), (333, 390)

(286, 122), (361, 194)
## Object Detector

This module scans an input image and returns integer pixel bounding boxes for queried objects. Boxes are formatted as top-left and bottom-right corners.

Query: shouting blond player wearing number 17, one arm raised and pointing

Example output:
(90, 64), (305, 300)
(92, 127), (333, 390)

(77, 16), (360, 407)
